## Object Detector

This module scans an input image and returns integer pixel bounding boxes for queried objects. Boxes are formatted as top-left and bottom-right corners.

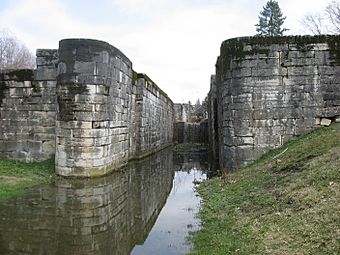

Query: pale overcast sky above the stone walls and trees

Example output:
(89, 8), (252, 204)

(0, 0), (328, 103)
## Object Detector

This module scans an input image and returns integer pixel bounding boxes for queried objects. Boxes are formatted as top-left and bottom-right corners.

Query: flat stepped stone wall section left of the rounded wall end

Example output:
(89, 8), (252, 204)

(0, 50), (58, 162)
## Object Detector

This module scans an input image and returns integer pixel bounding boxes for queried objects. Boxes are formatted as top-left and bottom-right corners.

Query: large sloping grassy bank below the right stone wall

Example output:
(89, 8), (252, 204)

(192, 124), (340, 255)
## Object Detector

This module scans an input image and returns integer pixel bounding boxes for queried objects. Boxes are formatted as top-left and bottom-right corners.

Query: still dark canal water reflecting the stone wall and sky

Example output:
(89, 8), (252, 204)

(0, 150), (208, 255)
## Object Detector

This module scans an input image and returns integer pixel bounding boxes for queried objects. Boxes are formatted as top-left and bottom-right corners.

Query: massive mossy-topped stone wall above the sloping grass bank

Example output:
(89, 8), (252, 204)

(209, 36), (340, 170)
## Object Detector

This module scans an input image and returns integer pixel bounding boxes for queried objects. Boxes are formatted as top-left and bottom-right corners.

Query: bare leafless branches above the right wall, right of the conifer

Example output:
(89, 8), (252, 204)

(302, 0), (340, 35)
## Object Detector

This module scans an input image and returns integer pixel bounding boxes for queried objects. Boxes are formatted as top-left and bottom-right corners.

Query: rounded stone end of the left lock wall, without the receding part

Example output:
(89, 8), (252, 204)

(56, 39), (132, 176)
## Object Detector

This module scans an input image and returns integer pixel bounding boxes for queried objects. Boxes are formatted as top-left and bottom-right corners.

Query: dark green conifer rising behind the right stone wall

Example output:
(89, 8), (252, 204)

(255, 0), (288, 36)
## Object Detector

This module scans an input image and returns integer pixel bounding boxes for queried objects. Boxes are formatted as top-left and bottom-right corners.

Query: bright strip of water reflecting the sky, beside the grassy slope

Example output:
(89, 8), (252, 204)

(132, 150), (208, 255)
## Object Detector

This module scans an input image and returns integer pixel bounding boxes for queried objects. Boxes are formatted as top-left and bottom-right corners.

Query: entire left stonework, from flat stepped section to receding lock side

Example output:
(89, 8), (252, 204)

(0, 39), (174, 176)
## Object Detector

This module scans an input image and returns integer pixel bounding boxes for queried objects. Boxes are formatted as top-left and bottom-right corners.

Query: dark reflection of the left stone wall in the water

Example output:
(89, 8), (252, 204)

(0, 150), (174, 255)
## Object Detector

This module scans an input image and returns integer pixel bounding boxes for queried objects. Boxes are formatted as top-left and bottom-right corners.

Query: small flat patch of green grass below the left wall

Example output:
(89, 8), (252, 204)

(0, 159), (54, 201)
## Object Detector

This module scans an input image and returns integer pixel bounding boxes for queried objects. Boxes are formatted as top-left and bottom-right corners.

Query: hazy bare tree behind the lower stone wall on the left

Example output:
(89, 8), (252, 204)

(0, 30), (35, 69)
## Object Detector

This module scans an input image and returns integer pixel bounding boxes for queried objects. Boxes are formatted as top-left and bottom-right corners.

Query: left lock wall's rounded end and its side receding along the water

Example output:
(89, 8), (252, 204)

(56, 39), (173, 176)
